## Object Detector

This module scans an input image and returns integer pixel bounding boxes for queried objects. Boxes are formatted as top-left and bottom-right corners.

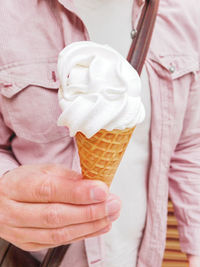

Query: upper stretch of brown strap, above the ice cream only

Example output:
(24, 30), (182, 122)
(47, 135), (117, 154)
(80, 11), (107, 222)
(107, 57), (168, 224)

(127, 0), (159, 75)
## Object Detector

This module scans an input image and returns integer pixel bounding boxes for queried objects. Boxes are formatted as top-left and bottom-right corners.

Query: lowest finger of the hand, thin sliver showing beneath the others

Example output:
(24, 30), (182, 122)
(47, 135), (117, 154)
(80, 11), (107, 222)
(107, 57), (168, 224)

(16, 224), (112, 251)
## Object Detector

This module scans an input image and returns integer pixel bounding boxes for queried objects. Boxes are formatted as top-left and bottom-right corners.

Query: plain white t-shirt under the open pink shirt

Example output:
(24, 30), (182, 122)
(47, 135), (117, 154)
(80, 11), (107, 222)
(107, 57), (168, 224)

(74, 0), (151, 267)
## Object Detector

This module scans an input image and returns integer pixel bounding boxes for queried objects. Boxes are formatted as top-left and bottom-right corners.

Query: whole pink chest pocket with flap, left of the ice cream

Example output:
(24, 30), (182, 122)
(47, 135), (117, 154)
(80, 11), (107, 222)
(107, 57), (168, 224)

(0, 62), (69, 143)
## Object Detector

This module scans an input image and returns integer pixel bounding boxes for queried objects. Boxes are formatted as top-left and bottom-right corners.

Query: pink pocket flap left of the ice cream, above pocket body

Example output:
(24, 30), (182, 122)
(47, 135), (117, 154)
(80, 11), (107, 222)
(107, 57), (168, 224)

(0, 62), (59, 98)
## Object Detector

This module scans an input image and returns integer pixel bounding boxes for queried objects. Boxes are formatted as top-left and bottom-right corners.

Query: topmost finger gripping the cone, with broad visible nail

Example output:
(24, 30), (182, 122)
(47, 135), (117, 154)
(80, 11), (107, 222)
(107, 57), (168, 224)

(4, 166), (108, 204)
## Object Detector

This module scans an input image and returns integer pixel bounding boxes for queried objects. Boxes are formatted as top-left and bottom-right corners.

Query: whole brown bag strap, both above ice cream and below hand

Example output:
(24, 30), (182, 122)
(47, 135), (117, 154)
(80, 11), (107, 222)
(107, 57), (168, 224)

(41, 0), (159, 267)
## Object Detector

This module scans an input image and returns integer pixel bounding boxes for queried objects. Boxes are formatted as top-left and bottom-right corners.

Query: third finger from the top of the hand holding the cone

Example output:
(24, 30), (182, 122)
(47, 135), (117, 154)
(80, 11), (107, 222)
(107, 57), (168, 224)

(5, 213), (119, 246)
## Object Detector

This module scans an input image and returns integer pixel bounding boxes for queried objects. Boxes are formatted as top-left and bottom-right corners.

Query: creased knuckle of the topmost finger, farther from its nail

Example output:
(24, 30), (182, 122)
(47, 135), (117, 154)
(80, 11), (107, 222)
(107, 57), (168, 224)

(35, 179), (54, 201)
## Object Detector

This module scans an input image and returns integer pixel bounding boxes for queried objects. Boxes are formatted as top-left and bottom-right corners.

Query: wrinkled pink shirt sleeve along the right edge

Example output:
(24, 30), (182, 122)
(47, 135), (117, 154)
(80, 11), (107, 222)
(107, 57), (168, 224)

(169, 70), (200, 255)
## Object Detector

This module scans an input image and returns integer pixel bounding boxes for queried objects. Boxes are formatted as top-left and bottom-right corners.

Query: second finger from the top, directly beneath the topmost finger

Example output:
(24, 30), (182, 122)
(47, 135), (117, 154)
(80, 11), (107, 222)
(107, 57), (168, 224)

(7, 195), (121, 228)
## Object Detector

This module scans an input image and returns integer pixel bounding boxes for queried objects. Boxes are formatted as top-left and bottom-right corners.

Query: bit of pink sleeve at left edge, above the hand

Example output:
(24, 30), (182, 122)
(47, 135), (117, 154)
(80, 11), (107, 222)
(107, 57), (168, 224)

(0, 107), (19, 177)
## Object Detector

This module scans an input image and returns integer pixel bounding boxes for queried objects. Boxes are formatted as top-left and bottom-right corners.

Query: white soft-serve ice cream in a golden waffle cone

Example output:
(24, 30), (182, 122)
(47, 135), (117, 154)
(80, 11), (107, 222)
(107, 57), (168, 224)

(58, 41), (145, 186)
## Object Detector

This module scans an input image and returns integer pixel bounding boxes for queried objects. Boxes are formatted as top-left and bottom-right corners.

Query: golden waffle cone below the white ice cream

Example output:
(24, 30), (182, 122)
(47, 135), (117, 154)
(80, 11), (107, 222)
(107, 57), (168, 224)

(76, 127), (135, 186)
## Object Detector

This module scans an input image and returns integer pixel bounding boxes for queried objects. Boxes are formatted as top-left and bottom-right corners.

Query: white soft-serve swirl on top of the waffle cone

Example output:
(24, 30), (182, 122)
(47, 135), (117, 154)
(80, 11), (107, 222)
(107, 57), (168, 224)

(58, 41), (145, 138)
